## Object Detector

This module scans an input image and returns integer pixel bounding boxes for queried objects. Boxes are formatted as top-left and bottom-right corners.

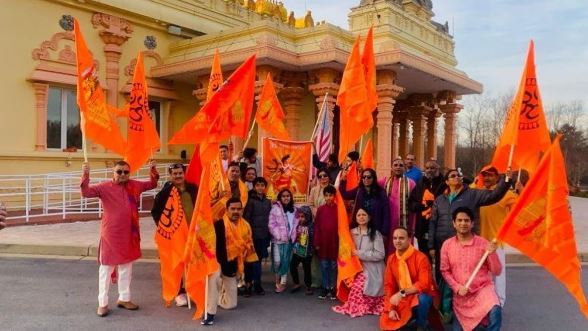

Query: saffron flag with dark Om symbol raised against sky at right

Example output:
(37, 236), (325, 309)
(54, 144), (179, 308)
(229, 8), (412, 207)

(492, 41), (551, 176)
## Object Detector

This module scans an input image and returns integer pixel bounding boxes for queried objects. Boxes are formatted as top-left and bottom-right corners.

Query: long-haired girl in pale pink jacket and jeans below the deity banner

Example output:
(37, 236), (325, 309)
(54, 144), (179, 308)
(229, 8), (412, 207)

(269, 189), (298, 293)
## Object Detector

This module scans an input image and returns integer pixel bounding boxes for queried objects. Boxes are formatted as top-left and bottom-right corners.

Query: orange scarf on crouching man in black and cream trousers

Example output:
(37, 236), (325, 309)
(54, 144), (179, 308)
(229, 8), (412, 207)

(223, 215), (258, 274)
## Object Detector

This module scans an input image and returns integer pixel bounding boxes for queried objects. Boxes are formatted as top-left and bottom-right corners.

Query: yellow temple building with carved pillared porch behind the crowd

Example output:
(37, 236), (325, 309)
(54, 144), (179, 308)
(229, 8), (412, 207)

(0, 0), (482, 179)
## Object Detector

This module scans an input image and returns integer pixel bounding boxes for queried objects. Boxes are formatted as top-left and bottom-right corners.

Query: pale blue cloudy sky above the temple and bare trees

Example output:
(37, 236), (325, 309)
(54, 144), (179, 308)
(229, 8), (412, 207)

(282, 0), (588, 106)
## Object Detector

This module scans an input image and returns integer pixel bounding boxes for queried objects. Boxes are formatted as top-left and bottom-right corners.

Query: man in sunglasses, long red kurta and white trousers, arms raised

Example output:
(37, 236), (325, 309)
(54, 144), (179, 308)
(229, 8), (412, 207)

(80, 161), (159, 317)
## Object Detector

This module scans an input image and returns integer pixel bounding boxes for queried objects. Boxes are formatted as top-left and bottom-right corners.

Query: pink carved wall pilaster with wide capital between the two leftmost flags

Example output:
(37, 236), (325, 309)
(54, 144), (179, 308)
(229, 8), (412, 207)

(92, 13), (133, 106)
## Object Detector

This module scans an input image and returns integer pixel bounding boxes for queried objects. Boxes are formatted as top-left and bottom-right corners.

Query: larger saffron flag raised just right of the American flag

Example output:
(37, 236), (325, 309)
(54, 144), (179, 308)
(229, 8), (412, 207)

(337, 36), (374, 160)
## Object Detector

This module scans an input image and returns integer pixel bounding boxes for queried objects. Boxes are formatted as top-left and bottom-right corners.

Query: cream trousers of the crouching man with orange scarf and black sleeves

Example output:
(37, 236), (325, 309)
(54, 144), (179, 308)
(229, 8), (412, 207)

(206, 270), (237, 315)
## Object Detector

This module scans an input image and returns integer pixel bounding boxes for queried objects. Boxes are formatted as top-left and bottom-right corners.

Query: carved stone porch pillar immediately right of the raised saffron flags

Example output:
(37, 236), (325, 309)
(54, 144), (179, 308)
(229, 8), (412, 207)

(375, 70), (404, 178)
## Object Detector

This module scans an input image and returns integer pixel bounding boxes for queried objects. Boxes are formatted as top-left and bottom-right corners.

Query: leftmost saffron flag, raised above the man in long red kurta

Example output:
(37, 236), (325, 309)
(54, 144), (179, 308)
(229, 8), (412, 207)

(74, 19), (126, 155)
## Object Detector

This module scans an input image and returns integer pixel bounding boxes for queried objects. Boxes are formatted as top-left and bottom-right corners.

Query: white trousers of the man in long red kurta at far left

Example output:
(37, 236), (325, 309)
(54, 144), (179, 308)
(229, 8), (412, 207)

(98, 262), (133, 307)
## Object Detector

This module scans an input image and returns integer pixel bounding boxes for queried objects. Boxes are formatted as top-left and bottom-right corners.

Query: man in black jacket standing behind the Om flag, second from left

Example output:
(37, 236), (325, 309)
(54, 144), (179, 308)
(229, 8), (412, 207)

(151, 163), (198, 307)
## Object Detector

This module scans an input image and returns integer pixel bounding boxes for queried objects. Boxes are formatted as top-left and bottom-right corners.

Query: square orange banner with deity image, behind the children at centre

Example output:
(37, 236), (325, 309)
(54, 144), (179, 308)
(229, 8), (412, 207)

(262, 138), (312, 203)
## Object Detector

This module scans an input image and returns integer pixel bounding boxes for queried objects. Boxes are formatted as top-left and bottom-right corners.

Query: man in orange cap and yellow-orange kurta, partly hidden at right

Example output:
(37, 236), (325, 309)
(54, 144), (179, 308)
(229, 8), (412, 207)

(480, 166), (517, 307)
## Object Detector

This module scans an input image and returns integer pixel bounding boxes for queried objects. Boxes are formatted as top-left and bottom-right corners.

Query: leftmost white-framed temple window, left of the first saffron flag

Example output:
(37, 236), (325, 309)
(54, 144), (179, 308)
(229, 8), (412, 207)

(47, 86), (82, 151)
